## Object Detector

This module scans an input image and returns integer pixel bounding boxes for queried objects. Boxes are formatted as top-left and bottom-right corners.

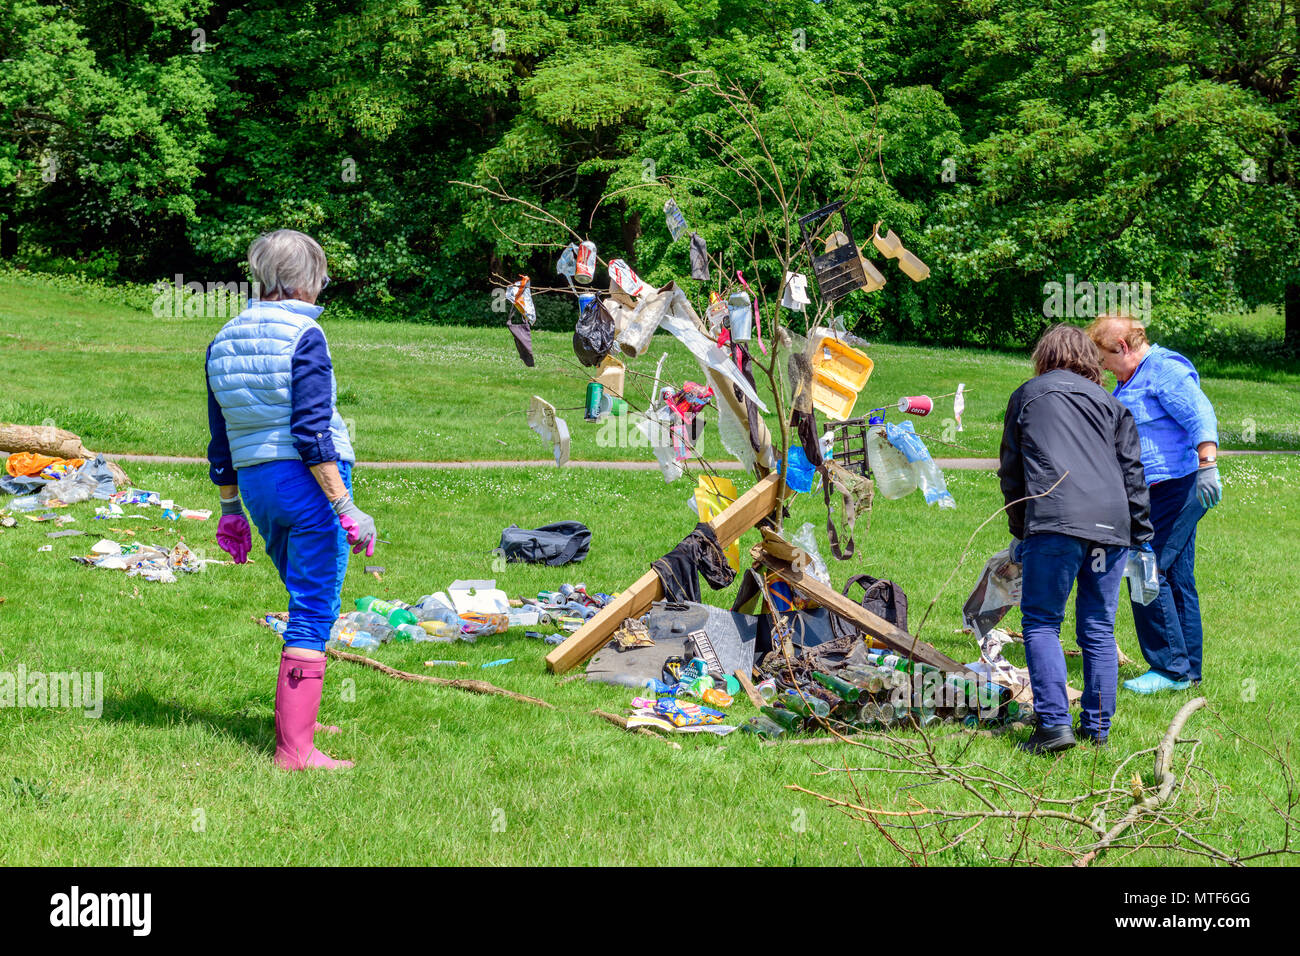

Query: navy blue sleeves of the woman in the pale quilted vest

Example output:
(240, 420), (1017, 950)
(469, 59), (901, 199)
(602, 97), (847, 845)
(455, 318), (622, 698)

(204, 329), (338, 485)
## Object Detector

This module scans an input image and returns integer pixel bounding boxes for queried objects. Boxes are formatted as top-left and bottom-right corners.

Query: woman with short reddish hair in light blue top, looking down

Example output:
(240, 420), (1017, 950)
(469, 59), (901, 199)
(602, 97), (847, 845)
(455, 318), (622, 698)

(1088, 315), (1223, 693)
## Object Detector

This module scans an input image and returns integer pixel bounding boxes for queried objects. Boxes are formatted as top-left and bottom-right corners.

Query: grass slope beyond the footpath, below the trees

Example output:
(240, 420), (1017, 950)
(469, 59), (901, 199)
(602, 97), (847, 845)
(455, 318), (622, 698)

(0, 276), (1300, 462)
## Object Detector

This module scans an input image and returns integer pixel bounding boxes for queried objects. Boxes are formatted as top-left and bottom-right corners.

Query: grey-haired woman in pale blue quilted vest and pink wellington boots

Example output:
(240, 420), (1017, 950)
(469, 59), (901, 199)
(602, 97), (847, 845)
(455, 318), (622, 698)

(207, 229), (376, 770)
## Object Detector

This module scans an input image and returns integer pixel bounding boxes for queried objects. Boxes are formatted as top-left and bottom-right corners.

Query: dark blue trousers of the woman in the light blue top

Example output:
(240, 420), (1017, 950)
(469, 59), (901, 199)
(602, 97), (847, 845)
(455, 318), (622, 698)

(1134, 471), (1205, 680)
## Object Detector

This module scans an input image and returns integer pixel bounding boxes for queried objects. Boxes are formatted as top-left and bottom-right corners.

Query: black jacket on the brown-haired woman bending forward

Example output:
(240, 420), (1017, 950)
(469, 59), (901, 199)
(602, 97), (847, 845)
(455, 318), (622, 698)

(997, 368), (1152, 548)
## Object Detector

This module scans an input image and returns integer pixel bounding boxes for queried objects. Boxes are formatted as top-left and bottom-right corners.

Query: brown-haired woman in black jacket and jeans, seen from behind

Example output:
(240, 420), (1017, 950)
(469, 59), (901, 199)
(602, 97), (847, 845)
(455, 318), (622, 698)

(997, 325), (1152, 753)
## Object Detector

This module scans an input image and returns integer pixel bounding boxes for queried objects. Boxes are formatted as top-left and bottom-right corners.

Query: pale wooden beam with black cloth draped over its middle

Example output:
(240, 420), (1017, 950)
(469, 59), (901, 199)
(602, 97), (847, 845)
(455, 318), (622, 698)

(546, 475), (785, 674)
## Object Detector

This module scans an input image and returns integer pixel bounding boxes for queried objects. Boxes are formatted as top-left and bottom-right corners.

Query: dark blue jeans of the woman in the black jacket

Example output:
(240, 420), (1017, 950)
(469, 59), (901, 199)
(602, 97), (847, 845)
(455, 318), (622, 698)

(1021, 532), (1128, 736)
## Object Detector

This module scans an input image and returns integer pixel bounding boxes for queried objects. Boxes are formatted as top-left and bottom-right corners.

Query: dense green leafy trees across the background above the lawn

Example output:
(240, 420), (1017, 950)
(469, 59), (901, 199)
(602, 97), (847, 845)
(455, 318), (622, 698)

(0, 0), (1300, 343)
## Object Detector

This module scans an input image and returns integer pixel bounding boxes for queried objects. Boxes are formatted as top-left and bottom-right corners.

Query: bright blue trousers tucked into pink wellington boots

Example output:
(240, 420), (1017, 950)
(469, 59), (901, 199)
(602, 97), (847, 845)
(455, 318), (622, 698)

(238, 458), (352, 650)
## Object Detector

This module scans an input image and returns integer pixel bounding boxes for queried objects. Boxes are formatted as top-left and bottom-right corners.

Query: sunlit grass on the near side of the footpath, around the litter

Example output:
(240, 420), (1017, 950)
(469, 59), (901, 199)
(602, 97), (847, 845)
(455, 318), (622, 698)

(0, 455), (1300, 865)
